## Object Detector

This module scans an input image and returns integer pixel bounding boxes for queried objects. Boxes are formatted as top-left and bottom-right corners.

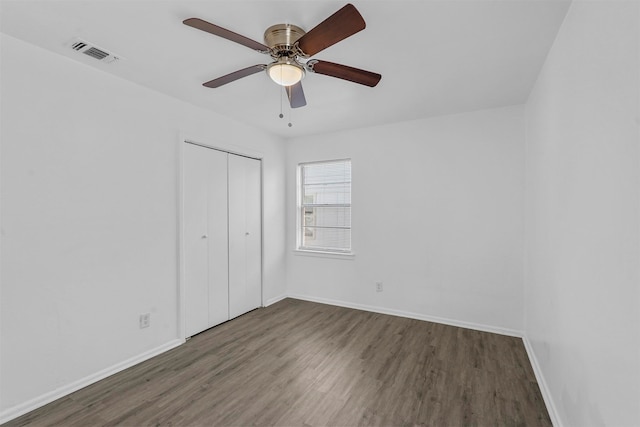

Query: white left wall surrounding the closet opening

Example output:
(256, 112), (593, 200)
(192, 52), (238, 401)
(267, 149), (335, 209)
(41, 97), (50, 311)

(0, 35), (286, 418)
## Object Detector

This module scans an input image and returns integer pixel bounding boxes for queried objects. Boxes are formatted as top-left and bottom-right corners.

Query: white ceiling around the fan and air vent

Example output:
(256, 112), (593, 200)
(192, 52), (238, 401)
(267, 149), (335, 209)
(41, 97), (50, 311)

(0, 0), (570, 138)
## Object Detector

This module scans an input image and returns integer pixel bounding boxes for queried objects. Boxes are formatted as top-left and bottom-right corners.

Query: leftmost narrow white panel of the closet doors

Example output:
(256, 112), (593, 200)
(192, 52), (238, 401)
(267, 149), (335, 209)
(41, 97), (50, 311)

(183, 144), (209, 336)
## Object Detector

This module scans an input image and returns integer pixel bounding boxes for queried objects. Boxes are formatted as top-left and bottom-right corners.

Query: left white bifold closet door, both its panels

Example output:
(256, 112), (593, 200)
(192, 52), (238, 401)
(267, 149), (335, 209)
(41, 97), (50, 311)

(183, 143), (229, 336)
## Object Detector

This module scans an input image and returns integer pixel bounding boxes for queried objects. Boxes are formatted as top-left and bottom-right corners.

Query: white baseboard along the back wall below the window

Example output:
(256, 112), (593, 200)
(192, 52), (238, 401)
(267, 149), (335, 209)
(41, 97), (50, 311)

(287, 294), (523, 338)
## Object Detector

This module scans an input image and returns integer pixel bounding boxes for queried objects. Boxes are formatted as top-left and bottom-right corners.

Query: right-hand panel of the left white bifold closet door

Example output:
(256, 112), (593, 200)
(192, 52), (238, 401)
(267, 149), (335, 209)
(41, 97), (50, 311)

(203, 148), (229, 327)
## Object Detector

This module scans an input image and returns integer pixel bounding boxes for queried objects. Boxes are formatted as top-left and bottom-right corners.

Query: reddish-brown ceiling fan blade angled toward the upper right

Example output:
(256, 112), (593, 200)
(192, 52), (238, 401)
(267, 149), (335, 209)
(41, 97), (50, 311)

(298, 4), (366, 56)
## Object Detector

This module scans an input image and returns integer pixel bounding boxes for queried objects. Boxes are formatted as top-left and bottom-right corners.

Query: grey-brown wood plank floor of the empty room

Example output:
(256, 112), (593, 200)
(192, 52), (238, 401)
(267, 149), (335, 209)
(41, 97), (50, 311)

(6, 299), (551, 427)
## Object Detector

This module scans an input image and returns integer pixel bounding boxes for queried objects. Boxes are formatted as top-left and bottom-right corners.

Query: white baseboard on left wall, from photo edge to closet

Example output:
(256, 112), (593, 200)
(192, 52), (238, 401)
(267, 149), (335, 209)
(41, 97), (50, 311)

(0, 339), (184, 424)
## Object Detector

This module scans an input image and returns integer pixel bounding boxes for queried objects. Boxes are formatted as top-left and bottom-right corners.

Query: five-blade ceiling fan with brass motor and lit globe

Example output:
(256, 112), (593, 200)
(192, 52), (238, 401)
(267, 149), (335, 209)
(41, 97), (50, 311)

(183, 4), (382, 108)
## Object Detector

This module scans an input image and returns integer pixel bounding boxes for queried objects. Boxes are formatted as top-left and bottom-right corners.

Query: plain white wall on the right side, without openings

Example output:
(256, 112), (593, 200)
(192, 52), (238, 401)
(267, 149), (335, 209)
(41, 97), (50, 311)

(525, 1), (640, 426)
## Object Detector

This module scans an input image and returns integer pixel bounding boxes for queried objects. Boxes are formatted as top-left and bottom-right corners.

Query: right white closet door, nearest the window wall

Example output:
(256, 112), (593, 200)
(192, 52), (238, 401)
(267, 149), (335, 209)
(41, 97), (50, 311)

(229, 154), (262, 318)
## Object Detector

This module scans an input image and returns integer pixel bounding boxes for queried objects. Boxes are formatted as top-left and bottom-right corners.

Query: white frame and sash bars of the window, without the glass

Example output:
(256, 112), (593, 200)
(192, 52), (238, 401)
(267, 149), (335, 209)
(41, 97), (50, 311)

(296, 158), (354, 258)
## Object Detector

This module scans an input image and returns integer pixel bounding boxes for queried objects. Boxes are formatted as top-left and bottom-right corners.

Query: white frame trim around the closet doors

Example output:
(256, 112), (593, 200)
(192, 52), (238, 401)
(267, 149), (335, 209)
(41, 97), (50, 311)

(176, 133), (265, 341)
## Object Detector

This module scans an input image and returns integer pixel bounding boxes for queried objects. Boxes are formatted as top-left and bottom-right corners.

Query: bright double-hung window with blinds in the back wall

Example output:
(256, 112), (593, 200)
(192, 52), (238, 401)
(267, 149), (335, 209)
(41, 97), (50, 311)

(298, 160), (351, 253)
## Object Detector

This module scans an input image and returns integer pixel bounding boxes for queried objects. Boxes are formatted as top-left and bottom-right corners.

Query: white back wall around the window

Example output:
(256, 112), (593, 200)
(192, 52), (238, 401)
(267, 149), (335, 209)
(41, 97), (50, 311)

(287, 106), (524, 332)
